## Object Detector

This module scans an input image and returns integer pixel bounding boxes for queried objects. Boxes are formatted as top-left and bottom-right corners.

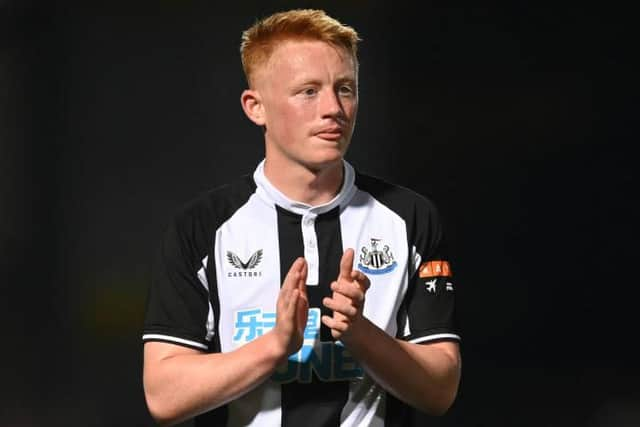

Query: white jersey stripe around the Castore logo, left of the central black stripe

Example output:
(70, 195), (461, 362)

(209, 195), (282, 427)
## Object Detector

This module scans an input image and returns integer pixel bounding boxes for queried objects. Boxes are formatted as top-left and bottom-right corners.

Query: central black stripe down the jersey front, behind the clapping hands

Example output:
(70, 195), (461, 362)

(278, 207), (349, 427)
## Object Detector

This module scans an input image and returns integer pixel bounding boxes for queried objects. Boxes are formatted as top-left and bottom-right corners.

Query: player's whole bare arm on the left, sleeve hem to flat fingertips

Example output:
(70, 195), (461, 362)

(143, 258), (308, 425)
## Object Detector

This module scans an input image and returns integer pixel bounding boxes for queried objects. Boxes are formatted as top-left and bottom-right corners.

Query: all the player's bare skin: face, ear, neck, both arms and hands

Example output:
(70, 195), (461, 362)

(143, 40), (460, 425)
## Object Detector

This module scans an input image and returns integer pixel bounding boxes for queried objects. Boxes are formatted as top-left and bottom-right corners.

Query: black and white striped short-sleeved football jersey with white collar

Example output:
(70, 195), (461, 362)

(143, 162), (459, 427)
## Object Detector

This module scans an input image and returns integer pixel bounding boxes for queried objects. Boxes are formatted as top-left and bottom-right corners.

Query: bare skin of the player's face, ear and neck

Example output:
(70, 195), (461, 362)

(241, 41), (358, 205)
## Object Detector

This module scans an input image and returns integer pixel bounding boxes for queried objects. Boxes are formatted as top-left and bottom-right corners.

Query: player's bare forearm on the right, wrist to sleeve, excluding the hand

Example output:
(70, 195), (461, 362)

(342, 317), (460, 415)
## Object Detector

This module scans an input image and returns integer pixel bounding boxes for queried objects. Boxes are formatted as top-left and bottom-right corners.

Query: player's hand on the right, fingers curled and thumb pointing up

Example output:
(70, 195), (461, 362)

(322, 249), (370, 339)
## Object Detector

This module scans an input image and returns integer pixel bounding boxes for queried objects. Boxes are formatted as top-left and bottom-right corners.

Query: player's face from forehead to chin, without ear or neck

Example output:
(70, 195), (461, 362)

(248, 41), (358, 170)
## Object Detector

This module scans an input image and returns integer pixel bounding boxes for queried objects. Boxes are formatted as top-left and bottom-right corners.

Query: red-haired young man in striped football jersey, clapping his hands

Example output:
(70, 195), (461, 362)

(143, 10), (460, 426)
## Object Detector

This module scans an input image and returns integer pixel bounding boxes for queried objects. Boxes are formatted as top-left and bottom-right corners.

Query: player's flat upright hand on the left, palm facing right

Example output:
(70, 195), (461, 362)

(273, 258), (309, 357)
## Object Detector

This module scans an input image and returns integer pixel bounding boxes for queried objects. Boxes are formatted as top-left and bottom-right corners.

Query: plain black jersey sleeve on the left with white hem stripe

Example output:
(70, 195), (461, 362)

(142, 214), (214, 351)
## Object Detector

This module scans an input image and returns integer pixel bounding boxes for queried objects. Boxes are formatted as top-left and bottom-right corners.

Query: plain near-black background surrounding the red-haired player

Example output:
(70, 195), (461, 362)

(0, 0), (640, 426)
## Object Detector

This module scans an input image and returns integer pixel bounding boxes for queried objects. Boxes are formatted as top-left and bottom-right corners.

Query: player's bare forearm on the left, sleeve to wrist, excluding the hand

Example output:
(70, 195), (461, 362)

(144, 333), (286, 425)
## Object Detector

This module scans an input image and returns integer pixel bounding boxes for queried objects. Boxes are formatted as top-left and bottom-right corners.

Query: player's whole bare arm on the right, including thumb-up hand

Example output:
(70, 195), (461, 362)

(322, 249), (461, 415)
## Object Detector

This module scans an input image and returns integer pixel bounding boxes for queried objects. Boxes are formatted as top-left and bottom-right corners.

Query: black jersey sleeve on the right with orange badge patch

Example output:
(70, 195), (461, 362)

(400, 198), (460, 343)
